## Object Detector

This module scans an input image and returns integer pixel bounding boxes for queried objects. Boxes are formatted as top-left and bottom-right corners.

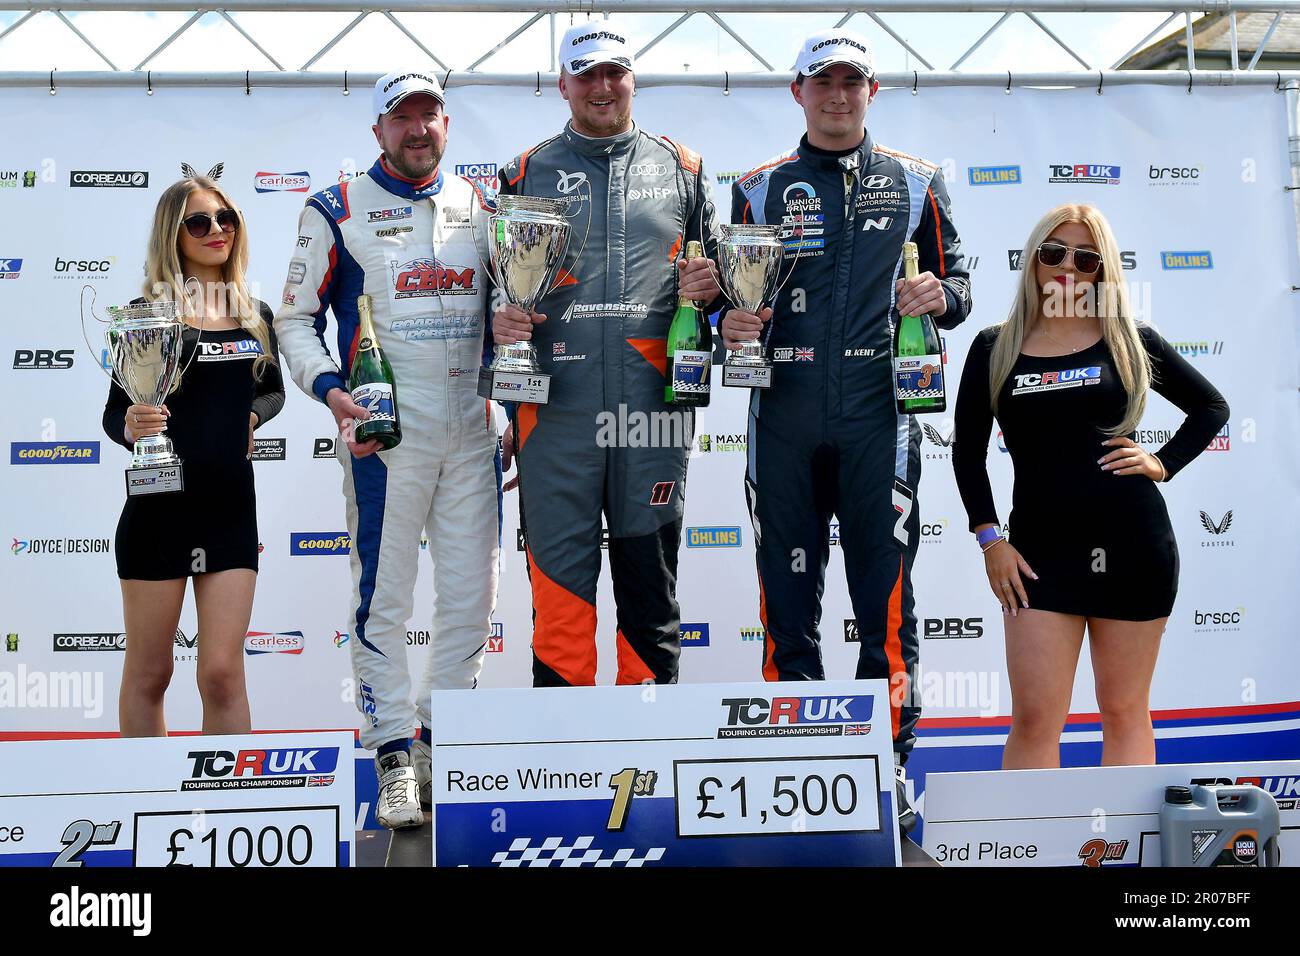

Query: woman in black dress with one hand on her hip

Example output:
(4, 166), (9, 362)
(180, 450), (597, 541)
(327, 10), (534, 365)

(953, 204), (1229, 769)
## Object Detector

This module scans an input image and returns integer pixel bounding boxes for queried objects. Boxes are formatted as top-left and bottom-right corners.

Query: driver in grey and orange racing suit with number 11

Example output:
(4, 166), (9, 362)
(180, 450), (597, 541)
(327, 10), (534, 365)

(493, 21), (719, 685)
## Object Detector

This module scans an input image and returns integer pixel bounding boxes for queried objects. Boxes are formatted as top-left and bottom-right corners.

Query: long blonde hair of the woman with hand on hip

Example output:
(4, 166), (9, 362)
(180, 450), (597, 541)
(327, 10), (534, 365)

(988, 203), (1151, 436)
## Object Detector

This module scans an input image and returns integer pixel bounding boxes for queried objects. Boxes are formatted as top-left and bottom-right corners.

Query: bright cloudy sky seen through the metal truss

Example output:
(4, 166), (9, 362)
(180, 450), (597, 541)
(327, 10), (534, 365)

(0, 12), (1183, 73)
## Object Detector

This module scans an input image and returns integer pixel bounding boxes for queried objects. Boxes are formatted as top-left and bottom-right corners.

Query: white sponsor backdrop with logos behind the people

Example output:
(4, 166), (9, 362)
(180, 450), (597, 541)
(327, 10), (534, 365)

(0, 87), (1300, 806)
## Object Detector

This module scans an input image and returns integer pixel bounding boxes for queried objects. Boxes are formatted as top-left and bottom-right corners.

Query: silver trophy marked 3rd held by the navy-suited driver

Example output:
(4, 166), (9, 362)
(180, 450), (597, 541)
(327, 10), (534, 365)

(718, 225), (789, 389)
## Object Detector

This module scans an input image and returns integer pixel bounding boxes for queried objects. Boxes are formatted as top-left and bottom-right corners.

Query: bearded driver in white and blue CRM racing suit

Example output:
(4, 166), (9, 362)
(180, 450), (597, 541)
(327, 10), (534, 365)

(276, 72), (501, 827)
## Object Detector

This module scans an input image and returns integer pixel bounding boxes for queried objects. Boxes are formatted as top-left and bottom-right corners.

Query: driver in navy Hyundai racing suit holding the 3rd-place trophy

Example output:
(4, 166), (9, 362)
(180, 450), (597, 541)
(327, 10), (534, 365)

(722, 30), (971, 825)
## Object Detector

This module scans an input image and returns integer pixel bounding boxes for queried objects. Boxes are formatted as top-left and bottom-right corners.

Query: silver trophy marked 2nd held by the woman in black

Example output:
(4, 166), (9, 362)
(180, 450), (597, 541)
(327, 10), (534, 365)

(82, 286), (185, 497)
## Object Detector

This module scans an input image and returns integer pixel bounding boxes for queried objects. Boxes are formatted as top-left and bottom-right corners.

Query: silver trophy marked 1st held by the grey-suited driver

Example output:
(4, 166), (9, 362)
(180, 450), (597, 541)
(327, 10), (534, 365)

(478, 195), (572, 405)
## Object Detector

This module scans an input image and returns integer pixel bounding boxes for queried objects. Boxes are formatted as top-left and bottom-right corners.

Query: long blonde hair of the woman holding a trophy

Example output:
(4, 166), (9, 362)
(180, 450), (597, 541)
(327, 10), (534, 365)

(144, 176), (274, 384)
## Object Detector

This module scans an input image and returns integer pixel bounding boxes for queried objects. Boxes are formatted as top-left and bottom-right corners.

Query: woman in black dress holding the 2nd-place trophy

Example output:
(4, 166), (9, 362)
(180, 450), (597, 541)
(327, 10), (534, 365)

(104, 177), (285, 736)
